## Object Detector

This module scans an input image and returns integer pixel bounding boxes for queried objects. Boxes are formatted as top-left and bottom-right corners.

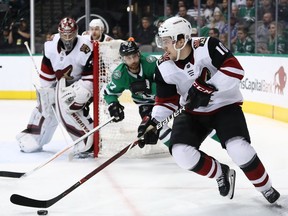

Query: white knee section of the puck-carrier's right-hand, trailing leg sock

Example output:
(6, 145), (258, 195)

(226, 137), (256, 166)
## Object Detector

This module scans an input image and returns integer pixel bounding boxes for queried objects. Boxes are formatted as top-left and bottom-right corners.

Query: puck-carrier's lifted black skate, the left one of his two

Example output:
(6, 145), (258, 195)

(216, 164), (236, 199)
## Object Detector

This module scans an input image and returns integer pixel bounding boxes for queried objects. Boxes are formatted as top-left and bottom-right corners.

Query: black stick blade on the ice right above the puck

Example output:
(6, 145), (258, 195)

(10, 194), (50, 208)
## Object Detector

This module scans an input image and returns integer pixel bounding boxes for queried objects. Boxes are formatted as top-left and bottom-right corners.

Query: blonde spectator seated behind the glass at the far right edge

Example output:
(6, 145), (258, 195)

(259, 22), (288, 54)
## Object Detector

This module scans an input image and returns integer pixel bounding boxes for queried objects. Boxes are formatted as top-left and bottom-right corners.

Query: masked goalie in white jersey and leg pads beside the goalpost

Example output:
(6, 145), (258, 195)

(16, 17), (93, 157)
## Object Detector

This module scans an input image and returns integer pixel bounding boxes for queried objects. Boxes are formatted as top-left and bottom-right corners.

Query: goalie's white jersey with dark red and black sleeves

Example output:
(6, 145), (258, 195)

(40, 34), (93, 89)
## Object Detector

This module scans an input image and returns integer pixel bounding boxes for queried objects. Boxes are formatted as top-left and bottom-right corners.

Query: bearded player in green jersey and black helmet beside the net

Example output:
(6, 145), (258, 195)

(104, 41), (171, 147)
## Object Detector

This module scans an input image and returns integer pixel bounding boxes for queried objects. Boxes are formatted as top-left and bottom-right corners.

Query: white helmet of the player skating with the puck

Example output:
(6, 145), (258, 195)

(156, 17), (192, 48)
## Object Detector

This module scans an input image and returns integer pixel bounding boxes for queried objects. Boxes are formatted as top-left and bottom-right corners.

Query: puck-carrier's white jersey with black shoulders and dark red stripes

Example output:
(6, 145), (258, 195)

(152, 37), (244, 121)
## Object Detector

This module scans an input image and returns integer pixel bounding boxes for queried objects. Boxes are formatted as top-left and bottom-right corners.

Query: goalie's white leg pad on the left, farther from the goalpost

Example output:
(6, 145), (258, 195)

(16, 107), (58, 153)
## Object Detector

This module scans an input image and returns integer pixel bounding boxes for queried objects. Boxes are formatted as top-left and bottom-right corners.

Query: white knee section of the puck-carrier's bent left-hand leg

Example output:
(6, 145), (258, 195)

(172, 143), (201, 170)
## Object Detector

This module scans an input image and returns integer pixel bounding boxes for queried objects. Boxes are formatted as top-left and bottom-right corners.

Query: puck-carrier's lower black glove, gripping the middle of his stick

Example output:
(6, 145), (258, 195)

(138, 116), (159, 148)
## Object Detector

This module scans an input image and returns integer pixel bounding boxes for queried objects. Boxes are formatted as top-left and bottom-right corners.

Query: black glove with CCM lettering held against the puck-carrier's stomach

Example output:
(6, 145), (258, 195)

(188, 78), (217, 110)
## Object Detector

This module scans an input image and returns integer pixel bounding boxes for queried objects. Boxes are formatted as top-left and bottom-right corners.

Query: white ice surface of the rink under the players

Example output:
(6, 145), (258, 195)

(0, 100), (288, 216)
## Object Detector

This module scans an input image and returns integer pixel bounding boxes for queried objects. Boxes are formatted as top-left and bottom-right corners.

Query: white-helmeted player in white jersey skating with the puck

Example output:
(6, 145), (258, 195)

(138, 17), (280, 203)
